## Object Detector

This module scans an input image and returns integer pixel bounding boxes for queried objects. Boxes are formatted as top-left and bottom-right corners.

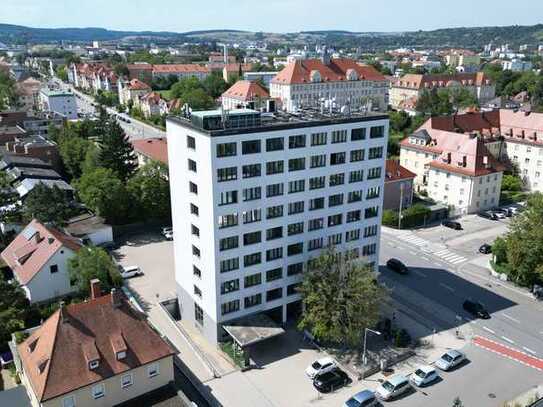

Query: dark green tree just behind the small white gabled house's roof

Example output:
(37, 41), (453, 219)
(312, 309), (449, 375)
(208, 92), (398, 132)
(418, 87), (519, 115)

(23, 183), (75, 226)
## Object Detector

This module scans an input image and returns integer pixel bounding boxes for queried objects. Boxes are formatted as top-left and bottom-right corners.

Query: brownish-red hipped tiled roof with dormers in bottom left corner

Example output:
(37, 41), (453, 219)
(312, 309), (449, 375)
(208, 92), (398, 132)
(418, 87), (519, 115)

(17, 291), (174, 402)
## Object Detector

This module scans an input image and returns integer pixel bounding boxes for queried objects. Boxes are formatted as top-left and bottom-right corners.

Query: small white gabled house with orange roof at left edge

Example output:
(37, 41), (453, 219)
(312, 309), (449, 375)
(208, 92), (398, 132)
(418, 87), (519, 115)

(1, 220), (82, 303)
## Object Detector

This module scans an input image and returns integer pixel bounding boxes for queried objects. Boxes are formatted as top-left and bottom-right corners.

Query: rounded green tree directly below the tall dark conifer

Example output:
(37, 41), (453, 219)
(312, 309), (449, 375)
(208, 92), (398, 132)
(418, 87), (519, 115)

(75, 168), (130, 224)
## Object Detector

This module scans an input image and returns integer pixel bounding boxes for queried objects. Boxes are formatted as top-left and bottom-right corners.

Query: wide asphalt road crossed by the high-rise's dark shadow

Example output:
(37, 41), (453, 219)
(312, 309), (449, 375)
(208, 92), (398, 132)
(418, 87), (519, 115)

(380, 227), (543, 406)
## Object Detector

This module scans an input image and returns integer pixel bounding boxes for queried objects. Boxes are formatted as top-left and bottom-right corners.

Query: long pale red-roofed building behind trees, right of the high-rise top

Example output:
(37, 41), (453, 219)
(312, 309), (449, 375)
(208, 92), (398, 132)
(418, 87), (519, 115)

(389, 72), (496, 109)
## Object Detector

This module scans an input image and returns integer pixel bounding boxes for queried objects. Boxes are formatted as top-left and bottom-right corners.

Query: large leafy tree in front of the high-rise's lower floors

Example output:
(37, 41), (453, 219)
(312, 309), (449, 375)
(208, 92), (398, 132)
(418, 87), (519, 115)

(299, 248), (388, 346)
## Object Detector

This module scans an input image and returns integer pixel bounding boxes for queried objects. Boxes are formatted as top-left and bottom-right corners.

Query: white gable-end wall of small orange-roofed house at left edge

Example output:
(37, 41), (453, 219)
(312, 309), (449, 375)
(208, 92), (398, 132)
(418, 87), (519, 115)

(23, 247), (77, 303)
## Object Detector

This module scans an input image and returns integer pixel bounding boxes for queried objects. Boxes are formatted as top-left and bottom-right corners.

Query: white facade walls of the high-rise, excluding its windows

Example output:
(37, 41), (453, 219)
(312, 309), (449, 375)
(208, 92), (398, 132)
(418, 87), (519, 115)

(167, 119), (388, 342)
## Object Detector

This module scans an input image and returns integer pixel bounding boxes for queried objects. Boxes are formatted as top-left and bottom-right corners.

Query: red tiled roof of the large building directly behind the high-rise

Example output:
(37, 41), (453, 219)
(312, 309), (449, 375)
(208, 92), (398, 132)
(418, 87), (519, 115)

(272, 59), (386, 84)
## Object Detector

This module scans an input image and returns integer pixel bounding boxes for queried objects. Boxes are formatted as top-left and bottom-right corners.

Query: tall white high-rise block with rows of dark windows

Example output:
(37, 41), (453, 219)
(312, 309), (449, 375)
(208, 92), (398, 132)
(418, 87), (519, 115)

(167, 109), (389, 343)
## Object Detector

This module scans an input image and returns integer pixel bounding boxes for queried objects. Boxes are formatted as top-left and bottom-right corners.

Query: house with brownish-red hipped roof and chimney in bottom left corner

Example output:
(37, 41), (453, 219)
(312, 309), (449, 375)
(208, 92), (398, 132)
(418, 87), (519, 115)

(15, 280), (174, 407)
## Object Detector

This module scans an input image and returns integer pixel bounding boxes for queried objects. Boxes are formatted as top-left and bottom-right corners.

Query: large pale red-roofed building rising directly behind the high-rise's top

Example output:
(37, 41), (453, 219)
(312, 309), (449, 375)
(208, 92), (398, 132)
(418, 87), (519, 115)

(270, 55), (388, 112)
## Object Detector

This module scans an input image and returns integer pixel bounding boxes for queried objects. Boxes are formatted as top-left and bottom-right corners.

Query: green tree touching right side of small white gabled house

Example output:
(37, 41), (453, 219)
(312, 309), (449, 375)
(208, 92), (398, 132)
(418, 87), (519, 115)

(68, 246), (122, 294)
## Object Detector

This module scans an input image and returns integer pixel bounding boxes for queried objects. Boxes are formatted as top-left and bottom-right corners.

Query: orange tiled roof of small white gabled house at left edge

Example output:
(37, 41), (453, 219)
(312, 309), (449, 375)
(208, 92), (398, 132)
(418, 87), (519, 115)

(1, 219), (81, 285)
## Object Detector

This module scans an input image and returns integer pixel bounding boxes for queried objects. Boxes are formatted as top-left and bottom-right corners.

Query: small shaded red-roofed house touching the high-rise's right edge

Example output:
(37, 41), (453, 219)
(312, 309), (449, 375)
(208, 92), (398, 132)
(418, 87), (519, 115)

(383, 160), (416, 210)
